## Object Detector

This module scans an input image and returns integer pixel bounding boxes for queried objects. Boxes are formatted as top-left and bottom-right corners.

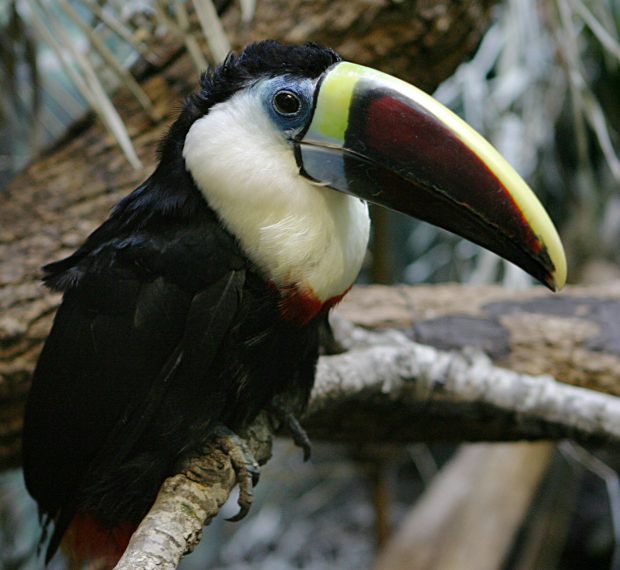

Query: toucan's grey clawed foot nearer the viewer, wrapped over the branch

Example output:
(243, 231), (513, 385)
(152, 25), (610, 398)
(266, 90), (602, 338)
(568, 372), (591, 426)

(213, 426), (260, 522)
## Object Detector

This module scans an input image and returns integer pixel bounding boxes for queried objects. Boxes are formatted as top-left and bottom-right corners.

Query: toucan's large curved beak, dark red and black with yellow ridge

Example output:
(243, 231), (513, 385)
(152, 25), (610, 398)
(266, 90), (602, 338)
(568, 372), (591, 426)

(295, 62), (566, 290)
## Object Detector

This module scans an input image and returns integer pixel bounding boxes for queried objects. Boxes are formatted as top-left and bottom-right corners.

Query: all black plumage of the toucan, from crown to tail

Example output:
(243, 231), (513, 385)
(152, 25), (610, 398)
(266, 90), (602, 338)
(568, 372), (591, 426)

(23, 42), (338, 552)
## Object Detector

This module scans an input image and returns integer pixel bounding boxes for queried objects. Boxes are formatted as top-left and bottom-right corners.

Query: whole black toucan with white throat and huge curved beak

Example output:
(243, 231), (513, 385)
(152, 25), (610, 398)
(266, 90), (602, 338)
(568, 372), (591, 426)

(23, 41), (566, 565)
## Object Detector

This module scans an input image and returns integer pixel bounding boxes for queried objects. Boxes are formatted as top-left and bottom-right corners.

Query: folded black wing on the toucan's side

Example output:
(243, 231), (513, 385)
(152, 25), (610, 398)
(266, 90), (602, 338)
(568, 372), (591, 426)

(23, 199), (247, 551)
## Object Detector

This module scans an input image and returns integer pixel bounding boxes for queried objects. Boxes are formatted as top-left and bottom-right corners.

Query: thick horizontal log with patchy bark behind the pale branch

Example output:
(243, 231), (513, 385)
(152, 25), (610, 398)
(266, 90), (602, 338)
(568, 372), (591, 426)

(320, 283), (620, 441)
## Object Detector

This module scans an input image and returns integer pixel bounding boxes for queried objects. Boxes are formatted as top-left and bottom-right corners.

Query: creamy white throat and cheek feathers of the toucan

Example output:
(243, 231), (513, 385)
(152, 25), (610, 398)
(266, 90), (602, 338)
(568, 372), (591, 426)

(183, 90), (370, 301)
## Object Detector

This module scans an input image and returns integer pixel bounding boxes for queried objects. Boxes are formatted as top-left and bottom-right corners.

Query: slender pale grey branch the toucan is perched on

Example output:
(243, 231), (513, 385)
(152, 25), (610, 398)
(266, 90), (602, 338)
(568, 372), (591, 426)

(116, 312), (620, 570)
